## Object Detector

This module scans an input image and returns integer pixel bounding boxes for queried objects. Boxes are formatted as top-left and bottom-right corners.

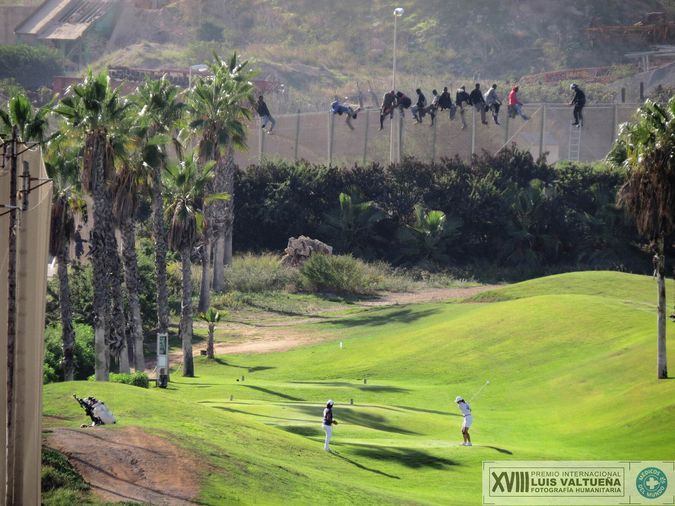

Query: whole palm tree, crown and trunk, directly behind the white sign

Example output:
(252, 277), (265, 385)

(135, 77), (185, 352)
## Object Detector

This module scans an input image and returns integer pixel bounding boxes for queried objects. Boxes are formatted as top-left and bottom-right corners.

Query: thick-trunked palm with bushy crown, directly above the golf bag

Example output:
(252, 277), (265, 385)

(55, 71), (131, 381)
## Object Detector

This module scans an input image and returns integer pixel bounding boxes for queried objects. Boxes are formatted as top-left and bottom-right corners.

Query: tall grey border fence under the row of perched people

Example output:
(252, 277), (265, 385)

(237, 104), (638, 166)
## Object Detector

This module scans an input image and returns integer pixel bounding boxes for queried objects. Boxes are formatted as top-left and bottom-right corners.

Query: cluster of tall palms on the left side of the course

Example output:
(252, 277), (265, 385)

(0, 54), (253, 381)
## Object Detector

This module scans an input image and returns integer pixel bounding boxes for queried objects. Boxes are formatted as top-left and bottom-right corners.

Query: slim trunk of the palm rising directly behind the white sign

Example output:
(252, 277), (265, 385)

(152, 166), (169, 340)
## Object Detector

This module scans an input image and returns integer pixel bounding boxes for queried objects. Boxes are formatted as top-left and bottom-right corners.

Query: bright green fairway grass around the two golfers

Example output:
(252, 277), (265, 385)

(44, 272), (675, 505)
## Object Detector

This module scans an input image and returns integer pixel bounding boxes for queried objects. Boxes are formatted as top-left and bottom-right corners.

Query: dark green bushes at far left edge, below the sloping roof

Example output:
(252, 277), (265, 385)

(0, 44), (63, 90)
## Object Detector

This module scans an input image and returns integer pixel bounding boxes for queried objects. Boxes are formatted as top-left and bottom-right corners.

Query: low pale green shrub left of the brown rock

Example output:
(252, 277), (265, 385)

(225, 253), (298, 292)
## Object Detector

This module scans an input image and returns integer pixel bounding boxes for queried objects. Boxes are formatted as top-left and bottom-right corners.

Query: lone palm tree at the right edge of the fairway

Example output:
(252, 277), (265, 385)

(608, 97), (675, 379)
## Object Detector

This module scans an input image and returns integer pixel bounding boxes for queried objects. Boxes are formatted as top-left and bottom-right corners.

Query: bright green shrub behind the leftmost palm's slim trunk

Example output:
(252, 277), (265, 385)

(42, 323), (95, 383)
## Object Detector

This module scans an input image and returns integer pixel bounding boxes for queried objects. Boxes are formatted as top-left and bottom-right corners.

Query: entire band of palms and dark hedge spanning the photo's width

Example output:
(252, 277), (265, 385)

(0, 47), (675, 381)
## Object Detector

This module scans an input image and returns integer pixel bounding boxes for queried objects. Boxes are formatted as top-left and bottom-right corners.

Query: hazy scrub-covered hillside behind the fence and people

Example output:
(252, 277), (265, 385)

(76, 0), (675, 108)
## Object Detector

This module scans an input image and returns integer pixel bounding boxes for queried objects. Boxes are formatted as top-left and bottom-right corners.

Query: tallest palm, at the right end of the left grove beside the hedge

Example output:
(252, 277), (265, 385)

(188, 53), (253, 302)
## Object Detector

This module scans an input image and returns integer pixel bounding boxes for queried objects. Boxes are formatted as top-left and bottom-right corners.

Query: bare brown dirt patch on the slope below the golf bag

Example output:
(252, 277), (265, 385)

(47, 427), (203, 506)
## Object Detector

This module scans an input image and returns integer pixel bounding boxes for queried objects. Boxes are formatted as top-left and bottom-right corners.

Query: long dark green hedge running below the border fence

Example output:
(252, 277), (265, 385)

(234, 147), (648, 275)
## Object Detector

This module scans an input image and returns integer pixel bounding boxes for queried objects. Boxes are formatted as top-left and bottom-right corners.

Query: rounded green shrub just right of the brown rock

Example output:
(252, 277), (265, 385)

(300, 255), (377, 295)
